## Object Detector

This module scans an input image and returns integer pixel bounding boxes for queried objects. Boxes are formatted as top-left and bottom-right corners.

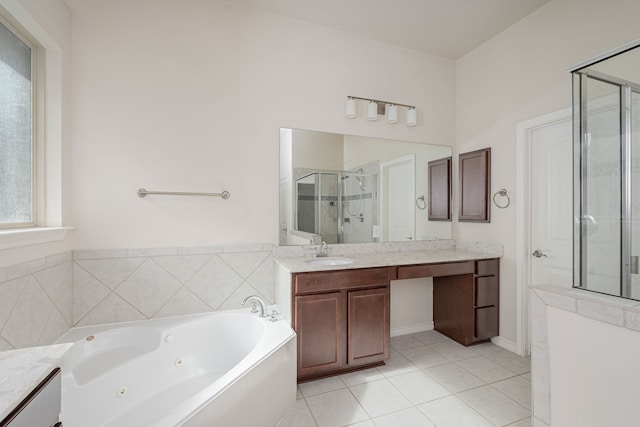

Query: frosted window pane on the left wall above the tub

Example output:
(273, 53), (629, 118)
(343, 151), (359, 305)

(0, 16), (35, 228)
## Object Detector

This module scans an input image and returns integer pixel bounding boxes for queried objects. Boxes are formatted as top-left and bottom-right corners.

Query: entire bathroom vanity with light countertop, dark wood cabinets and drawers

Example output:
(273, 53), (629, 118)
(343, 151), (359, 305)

(276, 245), (500, 382)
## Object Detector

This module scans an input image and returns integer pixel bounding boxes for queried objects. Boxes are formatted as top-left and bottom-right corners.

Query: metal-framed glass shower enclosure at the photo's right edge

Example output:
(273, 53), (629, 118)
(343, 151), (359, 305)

(571, 41), (640, 300)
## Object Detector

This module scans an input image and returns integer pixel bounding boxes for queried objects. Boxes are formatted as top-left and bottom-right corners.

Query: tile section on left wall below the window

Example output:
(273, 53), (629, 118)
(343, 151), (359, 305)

(0, 251), (73, 351)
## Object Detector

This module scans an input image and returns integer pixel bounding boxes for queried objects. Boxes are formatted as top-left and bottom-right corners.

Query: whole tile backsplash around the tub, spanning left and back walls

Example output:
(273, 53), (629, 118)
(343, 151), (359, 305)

(0, 243), (275, 351)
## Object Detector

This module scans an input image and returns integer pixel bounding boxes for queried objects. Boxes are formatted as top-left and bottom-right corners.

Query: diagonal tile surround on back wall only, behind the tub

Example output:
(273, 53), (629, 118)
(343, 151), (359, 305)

(73, 243), (275, 326)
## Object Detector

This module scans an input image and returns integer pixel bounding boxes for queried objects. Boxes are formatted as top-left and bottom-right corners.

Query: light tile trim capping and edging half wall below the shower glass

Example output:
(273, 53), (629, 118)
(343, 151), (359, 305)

(530, 286), (640, 427)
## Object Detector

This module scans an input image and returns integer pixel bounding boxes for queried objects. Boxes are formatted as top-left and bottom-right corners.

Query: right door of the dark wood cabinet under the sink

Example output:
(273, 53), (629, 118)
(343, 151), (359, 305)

(347, 286), (390, 366)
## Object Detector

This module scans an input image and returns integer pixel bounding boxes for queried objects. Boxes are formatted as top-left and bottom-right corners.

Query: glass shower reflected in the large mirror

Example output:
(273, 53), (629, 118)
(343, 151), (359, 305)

(294, 168), (378, 244)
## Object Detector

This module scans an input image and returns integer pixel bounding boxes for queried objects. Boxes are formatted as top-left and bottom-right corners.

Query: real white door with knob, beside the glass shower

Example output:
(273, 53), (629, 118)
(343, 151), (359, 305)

(516, 109), (573, 356)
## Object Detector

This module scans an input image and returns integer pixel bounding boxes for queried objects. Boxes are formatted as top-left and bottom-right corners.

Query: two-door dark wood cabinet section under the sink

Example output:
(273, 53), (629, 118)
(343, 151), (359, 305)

(293, 267), (390, 381)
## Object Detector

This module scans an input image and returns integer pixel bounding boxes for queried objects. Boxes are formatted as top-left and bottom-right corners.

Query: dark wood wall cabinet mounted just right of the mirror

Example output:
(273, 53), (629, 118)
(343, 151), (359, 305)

(458, 148), (491, 222)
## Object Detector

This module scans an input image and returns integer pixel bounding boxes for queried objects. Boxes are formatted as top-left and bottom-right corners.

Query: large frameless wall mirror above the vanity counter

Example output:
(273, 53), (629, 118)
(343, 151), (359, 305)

(279, 128), (451, 245)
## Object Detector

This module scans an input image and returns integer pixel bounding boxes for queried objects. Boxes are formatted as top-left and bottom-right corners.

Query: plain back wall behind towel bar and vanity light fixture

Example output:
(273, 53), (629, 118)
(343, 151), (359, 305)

(72, 0), (455, 249)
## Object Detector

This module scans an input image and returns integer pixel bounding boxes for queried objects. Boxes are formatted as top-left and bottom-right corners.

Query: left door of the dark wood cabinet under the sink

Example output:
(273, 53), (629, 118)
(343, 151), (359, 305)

(294, 292), (346, 377)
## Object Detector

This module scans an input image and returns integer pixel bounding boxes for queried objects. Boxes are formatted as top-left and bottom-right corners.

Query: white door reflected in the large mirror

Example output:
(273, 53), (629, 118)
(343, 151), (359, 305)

(381, 155), (415, 242)
